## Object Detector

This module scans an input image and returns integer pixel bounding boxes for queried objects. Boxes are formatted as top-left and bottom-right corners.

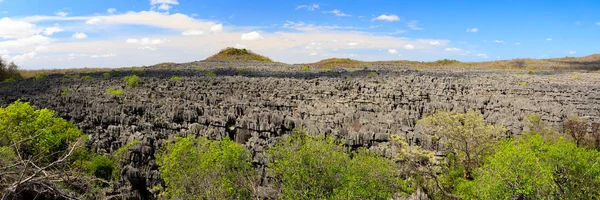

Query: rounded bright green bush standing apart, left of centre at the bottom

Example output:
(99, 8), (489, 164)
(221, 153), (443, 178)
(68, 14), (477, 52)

(156, 137), (257, 199)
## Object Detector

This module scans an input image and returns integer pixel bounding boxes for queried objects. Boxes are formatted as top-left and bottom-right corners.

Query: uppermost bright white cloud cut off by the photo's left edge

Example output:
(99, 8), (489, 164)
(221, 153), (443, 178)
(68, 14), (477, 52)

(0, 17), (40, 39)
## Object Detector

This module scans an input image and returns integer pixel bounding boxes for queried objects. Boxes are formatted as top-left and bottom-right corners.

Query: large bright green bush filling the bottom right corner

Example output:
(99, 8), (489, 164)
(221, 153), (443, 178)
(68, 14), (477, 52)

(460, 134), (600, 199)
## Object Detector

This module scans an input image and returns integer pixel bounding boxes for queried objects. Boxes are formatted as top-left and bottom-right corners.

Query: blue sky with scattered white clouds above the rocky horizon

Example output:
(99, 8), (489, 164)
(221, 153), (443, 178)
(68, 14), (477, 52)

(0, 0), (600, 69)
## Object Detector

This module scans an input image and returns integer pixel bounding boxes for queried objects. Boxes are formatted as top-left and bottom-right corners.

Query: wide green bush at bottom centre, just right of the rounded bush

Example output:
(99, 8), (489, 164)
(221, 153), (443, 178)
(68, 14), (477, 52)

(267, 130), (407, 199)
